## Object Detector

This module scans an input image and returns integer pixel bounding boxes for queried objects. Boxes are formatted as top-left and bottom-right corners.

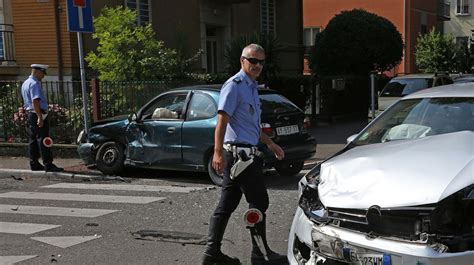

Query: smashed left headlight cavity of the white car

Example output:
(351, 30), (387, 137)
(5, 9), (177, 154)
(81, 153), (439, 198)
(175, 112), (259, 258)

(299, 164), (328, 224)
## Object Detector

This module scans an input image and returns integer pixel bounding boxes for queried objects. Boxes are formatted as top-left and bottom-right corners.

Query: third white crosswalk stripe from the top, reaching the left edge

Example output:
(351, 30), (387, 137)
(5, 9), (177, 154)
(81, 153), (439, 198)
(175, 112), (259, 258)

(0, 204), (118, 218)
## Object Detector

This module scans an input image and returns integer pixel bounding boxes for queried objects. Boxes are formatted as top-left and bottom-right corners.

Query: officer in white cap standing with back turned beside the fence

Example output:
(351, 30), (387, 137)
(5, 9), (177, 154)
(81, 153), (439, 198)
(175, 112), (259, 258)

(21, 64), (64, 172)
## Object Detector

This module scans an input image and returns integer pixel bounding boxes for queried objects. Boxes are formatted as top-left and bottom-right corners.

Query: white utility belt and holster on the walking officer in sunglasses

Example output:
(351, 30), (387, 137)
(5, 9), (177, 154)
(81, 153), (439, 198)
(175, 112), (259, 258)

(223, 144), (262, 179)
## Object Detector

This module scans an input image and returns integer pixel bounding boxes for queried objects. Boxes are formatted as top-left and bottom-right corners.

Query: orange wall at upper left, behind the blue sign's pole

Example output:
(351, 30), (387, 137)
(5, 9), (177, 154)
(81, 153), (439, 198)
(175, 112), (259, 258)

(12, 0), (78, 75)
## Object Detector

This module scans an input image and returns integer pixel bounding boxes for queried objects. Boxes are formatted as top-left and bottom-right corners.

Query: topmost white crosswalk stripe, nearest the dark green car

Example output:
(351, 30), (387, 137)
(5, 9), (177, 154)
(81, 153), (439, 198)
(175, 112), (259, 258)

(41, 183), (205, 193)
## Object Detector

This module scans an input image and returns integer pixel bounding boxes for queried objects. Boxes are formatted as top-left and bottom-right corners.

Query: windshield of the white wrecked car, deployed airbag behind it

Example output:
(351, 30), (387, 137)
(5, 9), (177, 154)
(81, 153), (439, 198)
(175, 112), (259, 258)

(353, 98), (474, 145)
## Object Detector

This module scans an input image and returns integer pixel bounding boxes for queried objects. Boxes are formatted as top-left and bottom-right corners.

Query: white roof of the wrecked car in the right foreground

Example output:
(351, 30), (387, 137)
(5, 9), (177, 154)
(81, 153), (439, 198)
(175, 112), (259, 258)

(403, 83), (474, 100)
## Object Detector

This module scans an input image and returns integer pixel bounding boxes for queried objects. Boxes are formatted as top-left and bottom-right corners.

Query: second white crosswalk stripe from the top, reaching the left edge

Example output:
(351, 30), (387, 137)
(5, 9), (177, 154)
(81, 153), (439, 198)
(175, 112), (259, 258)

(0, 191), (165, 204)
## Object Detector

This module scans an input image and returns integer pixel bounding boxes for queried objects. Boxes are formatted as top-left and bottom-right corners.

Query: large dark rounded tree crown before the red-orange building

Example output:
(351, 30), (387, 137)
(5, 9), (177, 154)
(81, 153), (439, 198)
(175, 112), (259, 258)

(310, 9), (403, 75)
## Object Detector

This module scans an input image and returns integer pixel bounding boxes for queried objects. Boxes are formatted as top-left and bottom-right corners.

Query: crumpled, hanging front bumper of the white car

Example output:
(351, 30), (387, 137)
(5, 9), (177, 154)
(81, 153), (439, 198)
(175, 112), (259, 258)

(287, 207), (474, 265)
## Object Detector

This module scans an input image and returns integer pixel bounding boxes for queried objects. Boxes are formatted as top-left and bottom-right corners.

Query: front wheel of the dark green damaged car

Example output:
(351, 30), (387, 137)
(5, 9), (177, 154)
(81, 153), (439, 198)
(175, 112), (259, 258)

(95, 142), (125, 175)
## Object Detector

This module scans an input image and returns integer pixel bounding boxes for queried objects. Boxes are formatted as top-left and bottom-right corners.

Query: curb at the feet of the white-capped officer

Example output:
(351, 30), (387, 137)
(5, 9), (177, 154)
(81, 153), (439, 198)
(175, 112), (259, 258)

(0, 169), (104, 181)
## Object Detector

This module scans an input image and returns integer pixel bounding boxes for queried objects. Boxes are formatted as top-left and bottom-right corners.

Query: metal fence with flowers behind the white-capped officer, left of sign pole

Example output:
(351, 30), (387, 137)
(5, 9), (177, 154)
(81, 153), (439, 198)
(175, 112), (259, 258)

(0, 81), (90, 144)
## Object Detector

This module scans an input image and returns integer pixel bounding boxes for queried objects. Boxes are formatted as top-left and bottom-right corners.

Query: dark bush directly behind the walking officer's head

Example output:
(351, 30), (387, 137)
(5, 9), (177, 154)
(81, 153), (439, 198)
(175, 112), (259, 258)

(224, 33), (283, 82)
